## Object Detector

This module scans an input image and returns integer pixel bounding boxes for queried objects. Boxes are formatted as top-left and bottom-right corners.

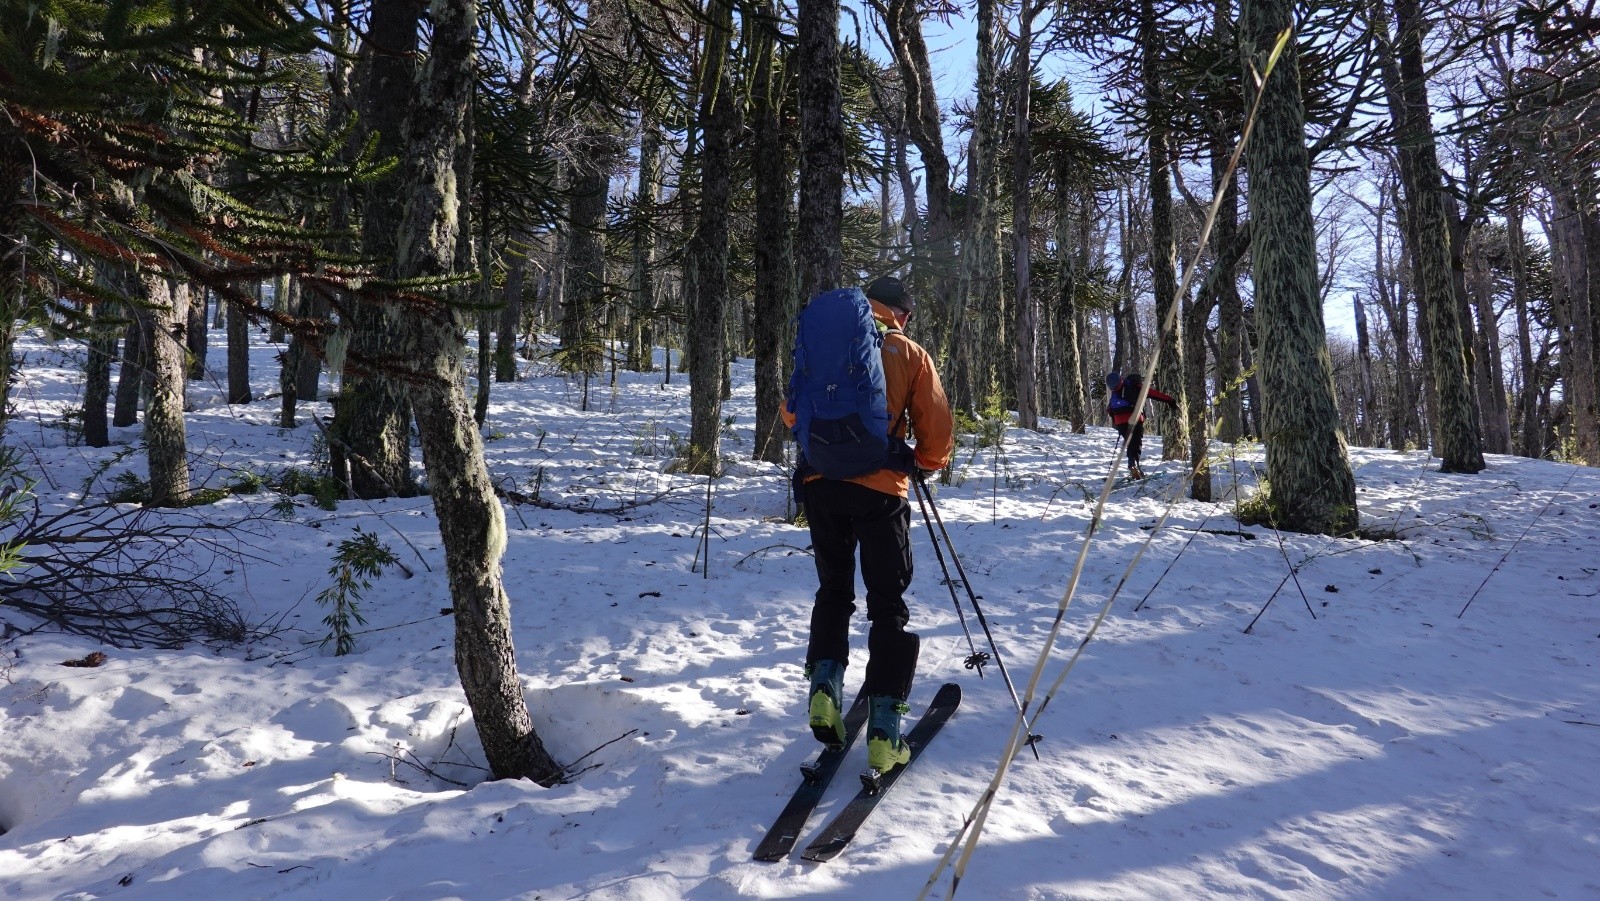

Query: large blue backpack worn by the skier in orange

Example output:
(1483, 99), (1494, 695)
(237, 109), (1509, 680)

(789, 288), (910, 479)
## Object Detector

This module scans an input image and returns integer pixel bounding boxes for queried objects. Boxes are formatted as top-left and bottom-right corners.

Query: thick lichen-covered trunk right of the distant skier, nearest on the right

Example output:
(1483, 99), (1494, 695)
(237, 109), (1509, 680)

(1238, 0), (1358, 535)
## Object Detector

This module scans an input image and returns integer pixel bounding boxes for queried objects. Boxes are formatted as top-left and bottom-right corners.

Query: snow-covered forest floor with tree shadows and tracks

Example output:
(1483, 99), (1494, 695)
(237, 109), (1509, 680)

(0, 326), (1600, 899)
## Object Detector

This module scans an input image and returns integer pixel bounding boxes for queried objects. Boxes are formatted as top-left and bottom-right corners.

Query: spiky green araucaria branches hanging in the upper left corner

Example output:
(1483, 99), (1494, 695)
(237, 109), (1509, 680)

(0, 0), (379, 409)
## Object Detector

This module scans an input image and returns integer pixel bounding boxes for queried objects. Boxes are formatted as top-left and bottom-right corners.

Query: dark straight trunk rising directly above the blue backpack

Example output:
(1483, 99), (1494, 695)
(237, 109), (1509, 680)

(793, 0), (845, 296)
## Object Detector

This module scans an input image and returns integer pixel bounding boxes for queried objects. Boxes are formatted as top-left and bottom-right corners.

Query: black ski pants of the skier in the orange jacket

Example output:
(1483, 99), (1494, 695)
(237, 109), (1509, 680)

(805, 479), (918, 701)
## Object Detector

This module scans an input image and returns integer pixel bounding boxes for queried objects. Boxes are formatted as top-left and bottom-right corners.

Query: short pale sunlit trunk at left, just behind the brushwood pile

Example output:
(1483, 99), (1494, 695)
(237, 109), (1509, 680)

(139, 270), (189, 507)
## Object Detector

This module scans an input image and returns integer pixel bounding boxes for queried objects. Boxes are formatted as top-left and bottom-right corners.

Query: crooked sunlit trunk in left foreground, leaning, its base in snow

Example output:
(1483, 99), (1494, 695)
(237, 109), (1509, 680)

(397, 0), (560, 784)
